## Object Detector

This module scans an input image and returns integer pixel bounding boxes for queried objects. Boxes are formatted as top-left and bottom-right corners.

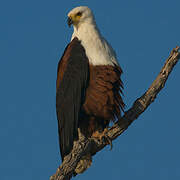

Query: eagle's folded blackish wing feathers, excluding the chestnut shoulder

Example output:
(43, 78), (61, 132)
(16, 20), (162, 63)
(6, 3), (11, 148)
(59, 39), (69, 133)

(56, 39), (89, 160)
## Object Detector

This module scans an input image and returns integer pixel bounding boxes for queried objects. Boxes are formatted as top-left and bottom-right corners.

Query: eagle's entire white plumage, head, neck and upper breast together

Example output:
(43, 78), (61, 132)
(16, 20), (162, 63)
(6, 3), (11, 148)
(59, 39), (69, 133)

(67, 6), (118, 66)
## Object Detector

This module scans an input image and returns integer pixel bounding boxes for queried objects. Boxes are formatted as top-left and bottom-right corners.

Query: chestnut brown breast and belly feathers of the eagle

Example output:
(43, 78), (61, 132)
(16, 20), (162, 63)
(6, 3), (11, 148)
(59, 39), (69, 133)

(83, 65), (124, 121)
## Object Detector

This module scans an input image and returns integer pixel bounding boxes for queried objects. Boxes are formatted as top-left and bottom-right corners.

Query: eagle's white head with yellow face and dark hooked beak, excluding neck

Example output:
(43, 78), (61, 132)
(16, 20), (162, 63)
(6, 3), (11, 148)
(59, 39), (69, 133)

(67, 6), (94, 29)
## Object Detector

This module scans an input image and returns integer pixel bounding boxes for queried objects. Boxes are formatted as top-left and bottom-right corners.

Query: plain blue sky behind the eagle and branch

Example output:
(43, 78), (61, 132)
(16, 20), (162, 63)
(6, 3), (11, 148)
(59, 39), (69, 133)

(0, 0), (180, 180)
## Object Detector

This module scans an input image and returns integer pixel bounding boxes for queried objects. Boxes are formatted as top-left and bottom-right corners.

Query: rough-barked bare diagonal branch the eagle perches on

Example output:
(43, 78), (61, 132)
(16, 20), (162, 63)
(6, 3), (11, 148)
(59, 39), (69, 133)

(50, 47), (180, 180)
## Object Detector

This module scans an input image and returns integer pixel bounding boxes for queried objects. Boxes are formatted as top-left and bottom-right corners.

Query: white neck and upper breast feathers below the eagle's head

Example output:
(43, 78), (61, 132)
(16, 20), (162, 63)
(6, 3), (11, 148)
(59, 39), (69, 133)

(71, 21), (118, 66)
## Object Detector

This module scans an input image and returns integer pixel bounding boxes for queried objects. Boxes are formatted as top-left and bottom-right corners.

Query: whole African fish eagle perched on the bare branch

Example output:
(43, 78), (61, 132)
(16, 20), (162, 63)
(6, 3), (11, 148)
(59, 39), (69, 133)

(56, 6), (124, 173)
